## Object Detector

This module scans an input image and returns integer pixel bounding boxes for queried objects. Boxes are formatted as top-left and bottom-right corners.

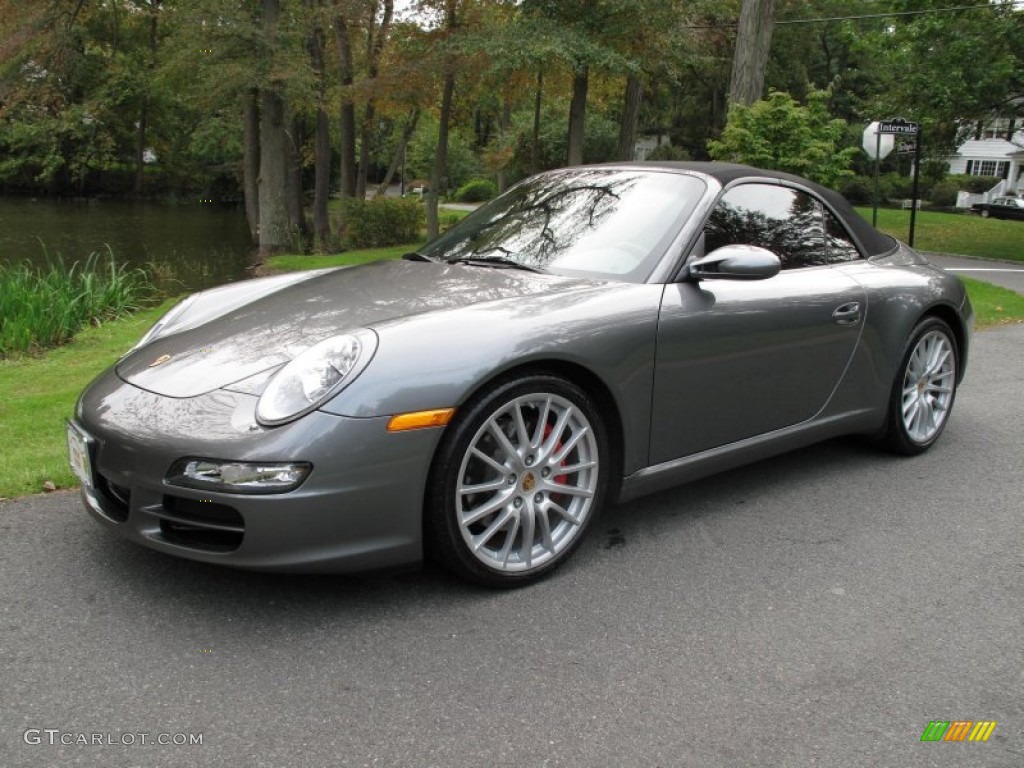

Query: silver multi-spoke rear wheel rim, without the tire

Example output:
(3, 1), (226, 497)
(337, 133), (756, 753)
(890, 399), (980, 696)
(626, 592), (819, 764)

(901, 331), (956, 444)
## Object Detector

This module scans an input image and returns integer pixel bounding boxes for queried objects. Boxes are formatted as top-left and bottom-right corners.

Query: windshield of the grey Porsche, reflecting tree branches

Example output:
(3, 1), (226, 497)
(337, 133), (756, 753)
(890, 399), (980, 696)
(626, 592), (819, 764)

(422, 168), (706, 283)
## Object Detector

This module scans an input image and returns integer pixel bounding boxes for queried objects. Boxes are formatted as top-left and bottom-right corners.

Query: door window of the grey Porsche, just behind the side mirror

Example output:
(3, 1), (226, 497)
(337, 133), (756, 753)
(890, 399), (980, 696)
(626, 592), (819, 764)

(705, 184), (828, 269)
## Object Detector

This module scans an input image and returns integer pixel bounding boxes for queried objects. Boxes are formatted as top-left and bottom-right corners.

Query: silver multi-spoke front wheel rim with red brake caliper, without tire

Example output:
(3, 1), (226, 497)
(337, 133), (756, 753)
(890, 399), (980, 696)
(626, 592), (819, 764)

(455, 392), (600, 572)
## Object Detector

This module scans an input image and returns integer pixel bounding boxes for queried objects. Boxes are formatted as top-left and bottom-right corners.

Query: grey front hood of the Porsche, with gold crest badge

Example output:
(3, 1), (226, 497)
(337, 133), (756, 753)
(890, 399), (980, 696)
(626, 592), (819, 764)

(117, 261), (593, 397)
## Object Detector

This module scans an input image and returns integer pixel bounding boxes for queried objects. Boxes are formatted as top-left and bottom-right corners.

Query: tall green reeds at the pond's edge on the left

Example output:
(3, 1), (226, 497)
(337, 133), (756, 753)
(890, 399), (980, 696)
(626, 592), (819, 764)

(0, 249), (154, 358)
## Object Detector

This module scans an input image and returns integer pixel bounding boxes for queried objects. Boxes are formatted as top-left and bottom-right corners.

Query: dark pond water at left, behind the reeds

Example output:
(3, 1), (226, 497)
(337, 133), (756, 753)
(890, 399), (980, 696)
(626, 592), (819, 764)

(0, 198), (255, 293)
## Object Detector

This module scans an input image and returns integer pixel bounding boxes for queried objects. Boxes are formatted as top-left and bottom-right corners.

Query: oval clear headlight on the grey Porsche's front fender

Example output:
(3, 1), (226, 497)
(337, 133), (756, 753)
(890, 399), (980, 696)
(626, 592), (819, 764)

(256, 329), (377, 426)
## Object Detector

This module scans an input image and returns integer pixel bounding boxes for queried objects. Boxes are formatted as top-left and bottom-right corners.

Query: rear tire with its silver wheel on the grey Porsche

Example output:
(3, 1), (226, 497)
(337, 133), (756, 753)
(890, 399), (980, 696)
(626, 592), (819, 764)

(882, 317), (959, 456)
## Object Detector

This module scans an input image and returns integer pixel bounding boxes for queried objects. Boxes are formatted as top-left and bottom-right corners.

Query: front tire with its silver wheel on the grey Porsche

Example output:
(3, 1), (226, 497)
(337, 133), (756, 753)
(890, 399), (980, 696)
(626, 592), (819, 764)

(425, 374), (611, 588)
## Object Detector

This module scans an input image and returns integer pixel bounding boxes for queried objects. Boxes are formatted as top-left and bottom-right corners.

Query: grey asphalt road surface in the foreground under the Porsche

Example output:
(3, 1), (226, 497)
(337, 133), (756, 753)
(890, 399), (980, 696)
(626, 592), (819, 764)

(0, 326), (1024, 768)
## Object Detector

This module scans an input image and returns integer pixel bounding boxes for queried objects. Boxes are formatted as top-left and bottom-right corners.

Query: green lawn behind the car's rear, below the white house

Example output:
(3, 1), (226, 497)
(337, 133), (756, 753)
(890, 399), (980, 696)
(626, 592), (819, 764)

(857, 208), (1024, 261)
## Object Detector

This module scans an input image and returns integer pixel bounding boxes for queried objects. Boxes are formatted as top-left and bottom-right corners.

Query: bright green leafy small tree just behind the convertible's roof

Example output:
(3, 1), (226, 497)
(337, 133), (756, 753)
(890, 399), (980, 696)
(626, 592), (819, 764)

(708, 90), (858, 186)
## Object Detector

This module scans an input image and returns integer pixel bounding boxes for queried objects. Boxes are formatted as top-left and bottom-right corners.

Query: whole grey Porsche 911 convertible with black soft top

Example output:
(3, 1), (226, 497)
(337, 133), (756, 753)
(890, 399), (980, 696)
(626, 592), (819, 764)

(68, 163), (973, 586)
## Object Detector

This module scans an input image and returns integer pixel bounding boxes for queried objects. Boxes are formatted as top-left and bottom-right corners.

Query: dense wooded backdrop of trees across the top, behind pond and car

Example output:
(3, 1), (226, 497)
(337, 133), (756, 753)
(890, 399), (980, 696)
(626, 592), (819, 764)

(0, 0), (1024, 250)
